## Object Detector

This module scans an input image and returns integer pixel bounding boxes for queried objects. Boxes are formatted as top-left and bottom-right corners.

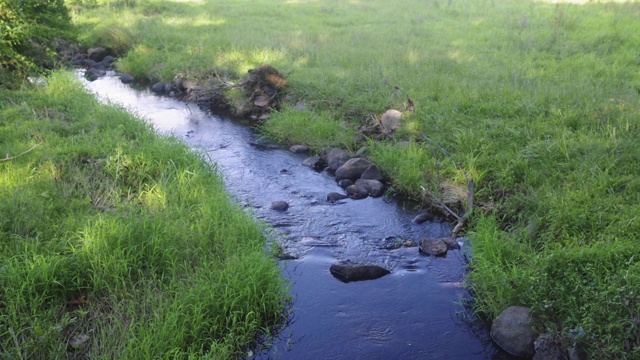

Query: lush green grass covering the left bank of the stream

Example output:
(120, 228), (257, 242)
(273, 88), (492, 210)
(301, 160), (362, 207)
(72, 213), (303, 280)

(0, 73), (288, 359)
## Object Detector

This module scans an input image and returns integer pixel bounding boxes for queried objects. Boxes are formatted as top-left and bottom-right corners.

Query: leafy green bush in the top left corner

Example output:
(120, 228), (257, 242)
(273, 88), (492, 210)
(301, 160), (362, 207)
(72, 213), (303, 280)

(0, 0), (73, 84)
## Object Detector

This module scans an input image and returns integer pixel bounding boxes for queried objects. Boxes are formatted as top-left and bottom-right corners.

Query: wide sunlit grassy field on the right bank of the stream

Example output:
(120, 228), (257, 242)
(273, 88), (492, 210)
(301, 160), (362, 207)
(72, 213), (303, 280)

(68, 0), (640, 359)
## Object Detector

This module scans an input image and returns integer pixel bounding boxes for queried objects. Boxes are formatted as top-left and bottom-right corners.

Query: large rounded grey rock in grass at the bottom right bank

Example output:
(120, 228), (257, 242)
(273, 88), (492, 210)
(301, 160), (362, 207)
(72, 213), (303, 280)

(491, 306), (535, 358)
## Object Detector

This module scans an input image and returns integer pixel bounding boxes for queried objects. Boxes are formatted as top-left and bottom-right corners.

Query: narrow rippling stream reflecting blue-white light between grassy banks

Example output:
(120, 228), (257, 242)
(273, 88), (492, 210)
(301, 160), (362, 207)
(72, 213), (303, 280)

(83, 76), (510, 359)
